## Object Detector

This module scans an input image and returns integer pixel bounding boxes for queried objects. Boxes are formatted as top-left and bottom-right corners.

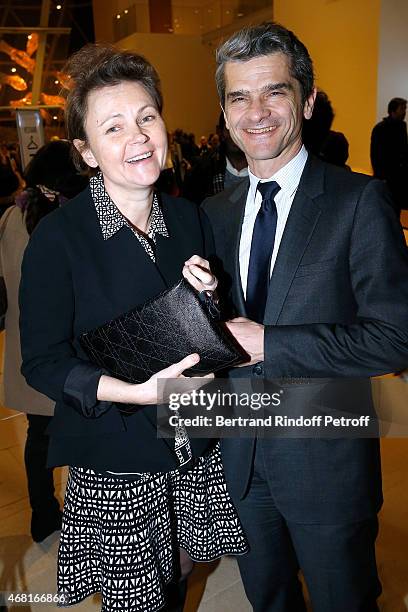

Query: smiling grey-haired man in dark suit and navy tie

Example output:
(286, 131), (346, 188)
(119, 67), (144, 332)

(203, 23), (408, 612)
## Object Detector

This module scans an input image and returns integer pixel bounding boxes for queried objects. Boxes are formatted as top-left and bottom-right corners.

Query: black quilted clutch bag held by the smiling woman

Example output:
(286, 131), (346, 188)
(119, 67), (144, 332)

(79, 279), (248, 383)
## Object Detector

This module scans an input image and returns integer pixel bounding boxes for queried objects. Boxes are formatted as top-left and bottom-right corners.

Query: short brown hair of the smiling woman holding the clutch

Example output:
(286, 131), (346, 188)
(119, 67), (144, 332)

(63, 44), (163, 169)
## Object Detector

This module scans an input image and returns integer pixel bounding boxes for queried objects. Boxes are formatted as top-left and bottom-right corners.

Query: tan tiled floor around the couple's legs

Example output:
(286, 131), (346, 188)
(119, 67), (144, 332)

(0, 376), (408, 612)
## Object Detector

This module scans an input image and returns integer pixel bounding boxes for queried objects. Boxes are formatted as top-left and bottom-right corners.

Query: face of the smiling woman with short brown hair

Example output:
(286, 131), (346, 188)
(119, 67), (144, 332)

(74, 81), (167, 191)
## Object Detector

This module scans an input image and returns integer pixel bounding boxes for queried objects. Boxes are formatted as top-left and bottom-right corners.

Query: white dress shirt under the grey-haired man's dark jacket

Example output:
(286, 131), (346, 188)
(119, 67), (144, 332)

(239, 146), (307, 297)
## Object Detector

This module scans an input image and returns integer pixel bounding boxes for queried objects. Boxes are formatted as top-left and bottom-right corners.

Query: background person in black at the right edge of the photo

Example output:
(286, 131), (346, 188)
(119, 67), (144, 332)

(370, 98), (408, 219)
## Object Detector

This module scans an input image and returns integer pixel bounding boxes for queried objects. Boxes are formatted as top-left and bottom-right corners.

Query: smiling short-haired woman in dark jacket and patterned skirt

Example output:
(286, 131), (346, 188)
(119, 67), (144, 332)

(20, 45), (246, 612)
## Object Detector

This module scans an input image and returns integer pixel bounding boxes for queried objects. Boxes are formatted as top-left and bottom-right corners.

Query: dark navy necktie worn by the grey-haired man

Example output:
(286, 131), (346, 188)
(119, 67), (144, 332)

(246, 181), (280, 323)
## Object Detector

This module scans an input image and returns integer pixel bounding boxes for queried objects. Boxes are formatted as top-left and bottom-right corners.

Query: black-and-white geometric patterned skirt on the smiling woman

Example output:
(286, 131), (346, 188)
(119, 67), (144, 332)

(58, 447), (248, 612)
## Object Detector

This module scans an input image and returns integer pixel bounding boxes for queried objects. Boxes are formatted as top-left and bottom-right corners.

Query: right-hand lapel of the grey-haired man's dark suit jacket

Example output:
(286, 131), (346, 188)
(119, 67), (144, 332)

(264, 156), (324, 325)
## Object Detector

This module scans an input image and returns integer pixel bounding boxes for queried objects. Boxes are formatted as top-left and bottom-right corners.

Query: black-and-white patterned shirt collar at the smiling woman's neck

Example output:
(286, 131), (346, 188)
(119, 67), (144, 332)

(89, 172), (169, 241)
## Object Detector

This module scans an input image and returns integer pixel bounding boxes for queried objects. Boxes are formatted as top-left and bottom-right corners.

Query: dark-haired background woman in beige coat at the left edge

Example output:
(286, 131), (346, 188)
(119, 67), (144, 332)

(0, 140), (87, 542)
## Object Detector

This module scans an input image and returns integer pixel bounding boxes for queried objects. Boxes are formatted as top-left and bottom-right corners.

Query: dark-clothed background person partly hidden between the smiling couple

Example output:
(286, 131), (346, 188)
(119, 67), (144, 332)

(183, 113), (248, 204)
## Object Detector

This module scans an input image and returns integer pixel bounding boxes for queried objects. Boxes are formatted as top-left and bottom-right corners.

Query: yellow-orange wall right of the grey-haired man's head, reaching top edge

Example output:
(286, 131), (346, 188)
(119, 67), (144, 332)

(275, 0), (380, 174)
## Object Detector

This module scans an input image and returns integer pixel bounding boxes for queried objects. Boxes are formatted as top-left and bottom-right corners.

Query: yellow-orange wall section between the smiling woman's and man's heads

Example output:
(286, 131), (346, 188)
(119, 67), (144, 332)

(118, 34), (220, 141)
